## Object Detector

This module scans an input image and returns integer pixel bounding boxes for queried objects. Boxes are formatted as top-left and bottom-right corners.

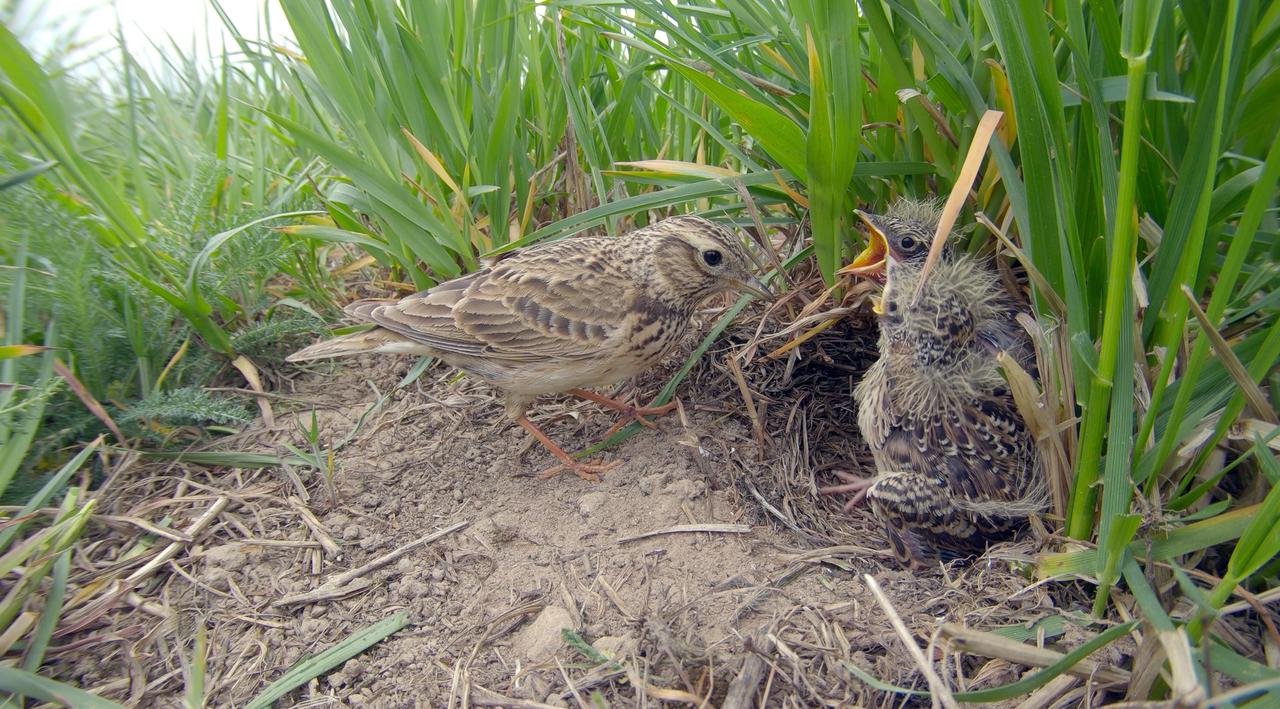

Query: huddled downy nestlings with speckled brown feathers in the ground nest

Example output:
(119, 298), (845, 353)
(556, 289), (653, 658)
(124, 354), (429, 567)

(820, 201), (1046, 567)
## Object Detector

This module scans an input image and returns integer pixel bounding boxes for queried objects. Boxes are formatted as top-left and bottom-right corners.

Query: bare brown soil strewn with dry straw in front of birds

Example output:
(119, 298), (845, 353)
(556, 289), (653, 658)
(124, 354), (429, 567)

(60, 316), (1100, 706)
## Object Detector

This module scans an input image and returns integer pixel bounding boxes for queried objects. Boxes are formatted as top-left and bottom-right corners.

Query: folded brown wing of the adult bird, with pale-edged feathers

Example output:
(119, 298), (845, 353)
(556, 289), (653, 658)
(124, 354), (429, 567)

(355, 239), (637, 362)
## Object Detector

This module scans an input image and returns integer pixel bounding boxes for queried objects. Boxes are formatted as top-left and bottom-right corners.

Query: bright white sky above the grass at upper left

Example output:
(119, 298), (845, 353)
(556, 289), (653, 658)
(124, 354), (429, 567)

(18, 0), (294, 72)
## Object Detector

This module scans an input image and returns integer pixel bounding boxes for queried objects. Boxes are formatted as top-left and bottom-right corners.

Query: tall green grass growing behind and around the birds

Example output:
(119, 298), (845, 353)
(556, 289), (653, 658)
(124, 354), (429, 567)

(0, 0), (1280, 699)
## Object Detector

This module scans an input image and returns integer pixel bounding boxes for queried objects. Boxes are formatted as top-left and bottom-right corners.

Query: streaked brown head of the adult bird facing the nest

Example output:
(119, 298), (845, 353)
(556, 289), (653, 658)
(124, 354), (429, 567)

(641, 216), (773, 307)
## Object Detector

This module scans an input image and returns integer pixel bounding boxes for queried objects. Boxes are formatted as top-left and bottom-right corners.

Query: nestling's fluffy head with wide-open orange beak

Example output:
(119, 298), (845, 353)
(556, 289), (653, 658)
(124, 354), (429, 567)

(838, 200), (950, 283)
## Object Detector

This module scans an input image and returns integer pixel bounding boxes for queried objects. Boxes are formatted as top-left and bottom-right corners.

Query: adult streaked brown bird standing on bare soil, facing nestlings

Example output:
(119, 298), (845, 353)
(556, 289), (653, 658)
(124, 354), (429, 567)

(288, 216), (772, 480)
